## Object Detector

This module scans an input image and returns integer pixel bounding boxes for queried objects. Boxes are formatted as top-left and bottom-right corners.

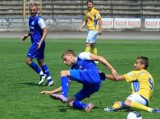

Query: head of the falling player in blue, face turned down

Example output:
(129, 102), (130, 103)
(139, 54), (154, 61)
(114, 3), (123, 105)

(61, 49), (76, 66)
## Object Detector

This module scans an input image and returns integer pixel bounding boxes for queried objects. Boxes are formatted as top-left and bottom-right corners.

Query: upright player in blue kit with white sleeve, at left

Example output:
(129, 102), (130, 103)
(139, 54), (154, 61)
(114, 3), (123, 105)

(21, 3), (54, 86)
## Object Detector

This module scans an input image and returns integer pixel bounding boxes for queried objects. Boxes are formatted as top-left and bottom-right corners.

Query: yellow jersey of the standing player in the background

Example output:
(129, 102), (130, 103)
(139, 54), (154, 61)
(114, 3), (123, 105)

(85, 8), (101, 30)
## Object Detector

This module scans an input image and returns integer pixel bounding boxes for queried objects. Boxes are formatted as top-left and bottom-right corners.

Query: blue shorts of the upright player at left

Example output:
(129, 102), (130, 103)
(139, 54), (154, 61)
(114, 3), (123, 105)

(27, 42), (45, 60)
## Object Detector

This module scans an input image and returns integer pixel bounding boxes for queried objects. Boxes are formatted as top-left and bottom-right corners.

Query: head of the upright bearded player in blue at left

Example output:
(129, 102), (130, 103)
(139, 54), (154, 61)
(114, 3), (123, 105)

(29, 3), (38, 17)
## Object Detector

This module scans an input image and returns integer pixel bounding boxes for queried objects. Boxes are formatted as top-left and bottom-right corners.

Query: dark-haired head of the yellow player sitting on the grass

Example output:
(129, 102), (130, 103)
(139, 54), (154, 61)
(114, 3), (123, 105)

(134, 56), (149, 70)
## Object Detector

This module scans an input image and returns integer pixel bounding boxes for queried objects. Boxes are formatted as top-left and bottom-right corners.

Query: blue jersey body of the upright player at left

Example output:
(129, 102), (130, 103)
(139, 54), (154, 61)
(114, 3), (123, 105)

(29, 15), (43, 43)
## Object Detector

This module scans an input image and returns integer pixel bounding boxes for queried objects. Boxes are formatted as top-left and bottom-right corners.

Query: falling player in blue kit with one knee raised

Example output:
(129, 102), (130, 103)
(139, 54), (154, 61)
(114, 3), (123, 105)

(50, 49), (116, 112)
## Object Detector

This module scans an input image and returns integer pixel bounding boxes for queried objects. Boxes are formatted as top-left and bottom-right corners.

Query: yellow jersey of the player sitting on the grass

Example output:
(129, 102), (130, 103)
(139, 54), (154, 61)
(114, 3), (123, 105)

(124, 70), (154, 101)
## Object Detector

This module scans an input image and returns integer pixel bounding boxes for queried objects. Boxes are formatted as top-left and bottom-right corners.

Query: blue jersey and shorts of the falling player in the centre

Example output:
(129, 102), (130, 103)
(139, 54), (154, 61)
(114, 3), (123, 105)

(70, 52), (101, 100)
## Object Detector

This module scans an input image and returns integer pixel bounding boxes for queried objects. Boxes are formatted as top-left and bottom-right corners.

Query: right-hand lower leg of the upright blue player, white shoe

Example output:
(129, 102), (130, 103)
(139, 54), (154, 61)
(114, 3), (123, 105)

(38, 59), (54, 86)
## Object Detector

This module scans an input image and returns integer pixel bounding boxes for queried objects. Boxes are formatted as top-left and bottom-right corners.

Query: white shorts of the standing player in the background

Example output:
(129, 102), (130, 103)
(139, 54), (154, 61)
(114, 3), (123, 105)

(86, 30), (98, 43)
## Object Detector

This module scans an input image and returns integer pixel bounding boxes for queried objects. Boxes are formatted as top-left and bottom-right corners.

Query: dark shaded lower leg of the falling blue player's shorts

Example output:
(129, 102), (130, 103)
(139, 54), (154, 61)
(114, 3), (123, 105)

(74, 83), (101, 101)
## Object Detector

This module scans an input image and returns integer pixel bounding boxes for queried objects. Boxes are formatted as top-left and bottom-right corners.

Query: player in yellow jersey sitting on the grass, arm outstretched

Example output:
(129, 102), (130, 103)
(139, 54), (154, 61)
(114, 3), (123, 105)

(104, 56), (160, 113)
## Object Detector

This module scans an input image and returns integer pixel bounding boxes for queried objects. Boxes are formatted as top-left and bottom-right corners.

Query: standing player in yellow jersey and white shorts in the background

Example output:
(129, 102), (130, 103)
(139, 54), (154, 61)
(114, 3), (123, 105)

(78, 0), (102, 55)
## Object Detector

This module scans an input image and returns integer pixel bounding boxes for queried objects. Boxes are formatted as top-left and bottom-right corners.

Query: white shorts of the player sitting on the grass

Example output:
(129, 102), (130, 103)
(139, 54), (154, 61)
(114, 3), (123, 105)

(127, 93), (147, 105)
